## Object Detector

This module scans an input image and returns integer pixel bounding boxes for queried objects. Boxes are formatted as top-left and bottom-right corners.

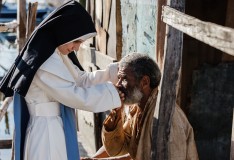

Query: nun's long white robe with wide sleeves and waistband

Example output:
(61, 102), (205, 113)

(24, 52), (121, 160)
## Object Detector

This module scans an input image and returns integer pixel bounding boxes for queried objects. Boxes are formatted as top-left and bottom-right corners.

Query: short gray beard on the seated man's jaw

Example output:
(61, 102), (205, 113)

(124, 87), (143, 105)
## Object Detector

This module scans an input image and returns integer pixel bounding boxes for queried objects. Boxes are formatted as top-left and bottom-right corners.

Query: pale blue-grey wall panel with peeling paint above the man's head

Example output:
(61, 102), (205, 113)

(121, 0), (156, 59)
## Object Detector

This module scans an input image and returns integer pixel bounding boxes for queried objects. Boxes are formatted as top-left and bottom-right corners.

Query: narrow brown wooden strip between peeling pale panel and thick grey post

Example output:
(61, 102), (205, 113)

(156, 0), (167, 71)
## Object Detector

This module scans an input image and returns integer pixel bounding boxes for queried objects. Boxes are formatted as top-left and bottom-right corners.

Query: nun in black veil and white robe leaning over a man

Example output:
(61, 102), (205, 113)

(0, 1), (123, 160)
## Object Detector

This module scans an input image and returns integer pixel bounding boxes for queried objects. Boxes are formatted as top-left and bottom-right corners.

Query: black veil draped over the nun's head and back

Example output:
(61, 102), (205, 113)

(0, 1), (96, 97)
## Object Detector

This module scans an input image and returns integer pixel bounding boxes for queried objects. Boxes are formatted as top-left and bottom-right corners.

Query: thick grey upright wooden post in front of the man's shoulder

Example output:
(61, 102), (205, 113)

(151, 0), (185, 160)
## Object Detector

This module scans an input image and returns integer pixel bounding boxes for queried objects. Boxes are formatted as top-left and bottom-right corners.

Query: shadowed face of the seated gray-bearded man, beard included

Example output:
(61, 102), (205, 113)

(117, 68), (143, 105)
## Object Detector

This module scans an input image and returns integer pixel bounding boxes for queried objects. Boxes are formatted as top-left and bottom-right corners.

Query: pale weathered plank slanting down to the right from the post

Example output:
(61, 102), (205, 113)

(162, 6), (234, 56)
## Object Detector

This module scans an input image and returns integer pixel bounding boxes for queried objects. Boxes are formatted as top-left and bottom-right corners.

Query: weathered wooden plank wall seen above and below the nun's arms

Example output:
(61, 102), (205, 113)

(77, 0), (122, 153)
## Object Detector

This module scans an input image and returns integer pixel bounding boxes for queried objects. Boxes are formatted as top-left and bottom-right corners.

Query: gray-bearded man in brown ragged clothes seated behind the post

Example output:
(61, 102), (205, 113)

(82, 53), (198, 160)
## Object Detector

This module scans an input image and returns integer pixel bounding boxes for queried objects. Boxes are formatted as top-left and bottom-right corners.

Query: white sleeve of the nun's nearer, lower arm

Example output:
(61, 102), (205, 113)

(34, 69), (121, 112)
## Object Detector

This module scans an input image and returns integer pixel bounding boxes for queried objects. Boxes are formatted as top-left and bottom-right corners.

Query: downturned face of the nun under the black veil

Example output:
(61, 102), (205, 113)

(58, 41), (82, 55)
